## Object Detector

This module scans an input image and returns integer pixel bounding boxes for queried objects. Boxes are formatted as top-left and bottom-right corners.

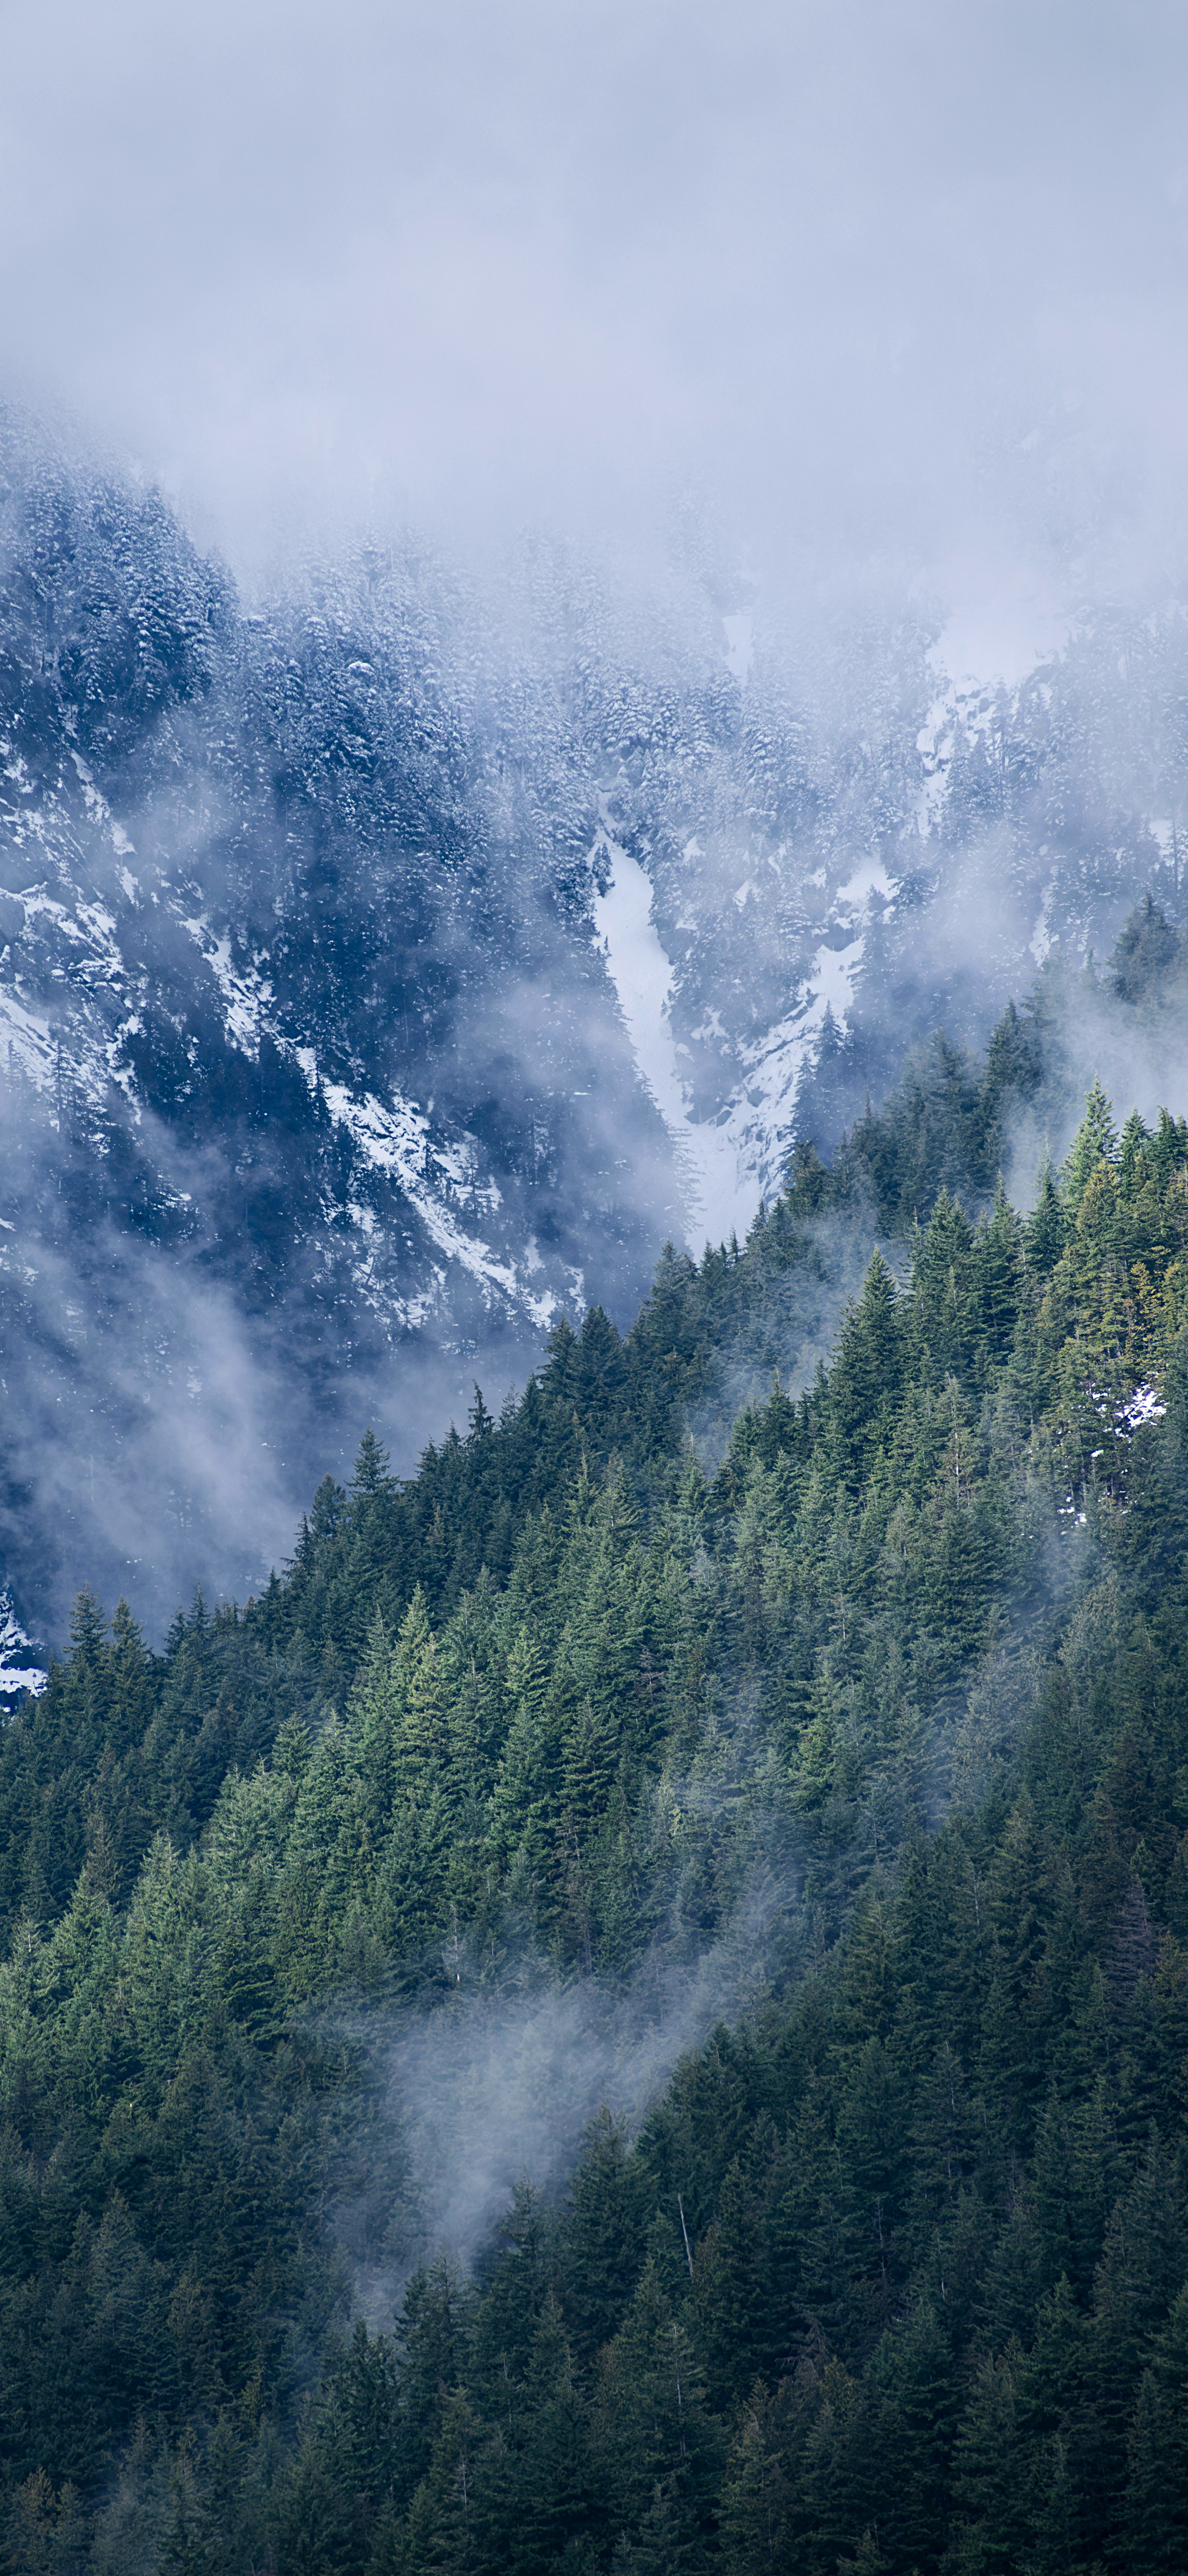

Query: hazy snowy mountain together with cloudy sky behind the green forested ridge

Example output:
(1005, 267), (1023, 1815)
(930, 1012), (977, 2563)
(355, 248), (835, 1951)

(0, 0), (1188, 1669)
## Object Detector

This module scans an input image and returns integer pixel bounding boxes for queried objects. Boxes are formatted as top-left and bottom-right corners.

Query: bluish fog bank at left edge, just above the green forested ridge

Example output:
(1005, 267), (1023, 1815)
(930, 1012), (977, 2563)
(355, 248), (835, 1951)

(0, 1072), (528, 1646)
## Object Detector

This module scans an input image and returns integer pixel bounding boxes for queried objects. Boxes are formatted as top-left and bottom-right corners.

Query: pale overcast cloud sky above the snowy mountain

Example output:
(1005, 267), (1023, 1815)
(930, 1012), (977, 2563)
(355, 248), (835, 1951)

(0, 0), (1188, 659)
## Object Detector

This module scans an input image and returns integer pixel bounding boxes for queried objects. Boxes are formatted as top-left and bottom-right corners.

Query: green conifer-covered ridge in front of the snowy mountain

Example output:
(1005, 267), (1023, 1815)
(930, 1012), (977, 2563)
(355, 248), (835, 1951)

(0, 907), (1188, 2576)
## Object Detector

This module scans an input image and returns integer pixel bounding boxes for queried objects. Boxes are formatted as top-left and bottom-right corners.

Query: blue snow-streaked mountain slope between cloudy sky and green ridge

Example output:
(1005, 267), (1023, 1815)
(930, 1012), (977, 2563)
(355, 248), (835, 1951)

(0, 422), (1188, 1623)
